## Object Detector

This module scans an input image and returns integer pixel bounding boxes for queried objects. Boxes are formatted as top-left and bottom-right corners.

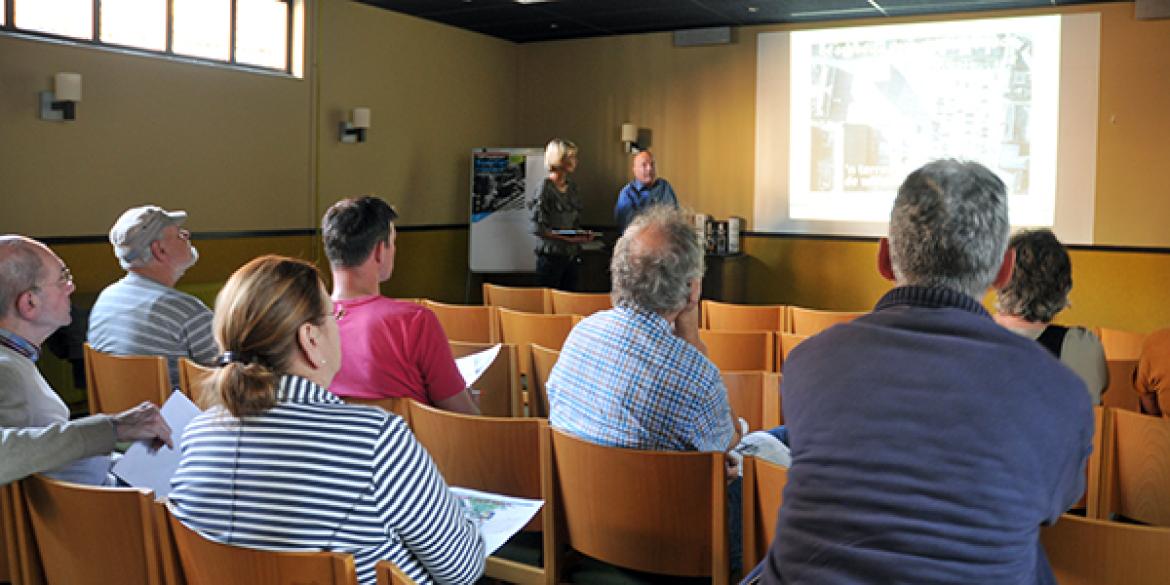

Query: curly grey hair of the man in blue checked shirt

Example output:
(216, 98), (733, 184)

(610, 205), (704, 314)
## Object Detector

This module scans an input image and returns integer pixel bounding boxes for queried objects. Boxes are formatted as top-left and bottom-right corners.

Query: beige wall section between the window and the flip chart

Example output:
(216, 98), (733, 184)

(318, 1), (521, 225)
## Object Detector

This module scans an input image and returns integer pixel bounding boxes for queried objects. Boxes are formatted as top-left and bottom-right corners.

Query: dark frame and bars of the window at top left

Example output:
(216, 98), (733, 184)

(0, 0), (297, 77)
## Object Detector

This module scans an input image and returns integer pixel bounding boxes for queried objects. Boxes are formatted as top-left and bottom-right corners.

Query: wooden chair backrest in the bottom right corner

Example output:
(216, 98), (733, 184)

(1040, 514), (1170, 585)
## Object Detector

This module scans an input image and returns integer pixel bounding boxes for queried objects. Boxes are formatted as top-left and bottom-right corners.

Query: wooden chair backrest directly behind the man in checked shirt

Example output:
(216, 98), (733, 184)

(552, 431), (729, 585)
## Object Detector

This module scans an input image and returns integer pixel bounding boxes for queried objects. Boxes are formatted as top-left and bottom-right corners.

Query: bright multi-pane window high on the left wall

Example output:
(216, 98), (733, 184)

(0, 0), (294, 73)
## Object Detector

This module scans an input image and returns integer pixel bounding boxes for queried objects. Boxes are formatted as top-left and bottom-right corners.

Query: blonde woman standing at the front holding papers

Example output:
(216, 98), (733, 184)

(530, 138), (593, 290)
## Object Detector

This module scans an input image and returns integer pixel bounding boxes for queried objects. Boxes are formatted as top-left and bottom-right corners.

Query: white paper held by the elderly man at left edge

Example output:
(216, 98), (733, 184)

(113, 391), (201, 498)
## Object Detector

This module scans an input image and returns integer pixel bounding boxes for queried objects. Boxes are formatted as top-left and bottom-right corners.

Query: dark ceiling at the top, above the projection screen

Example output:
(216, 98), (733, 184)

(358, 0), (1123, 42)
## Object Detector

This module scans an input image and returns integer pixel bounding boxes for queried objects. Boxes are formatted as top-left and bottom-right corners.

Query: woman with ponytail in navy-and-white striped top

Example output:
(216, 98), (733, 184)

(171, 256), (484, 585)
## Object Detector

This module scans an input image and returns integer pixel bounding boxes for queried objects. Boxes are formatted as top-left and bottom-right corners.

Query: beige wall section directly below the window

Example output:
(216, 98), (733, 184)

(0, 28), (312, 236)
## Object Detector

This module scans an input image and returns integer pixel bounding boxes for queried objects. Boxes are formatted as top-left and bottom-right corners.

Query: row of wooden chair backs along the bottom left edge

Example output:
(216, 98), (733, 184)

(0, 475), (413, 585)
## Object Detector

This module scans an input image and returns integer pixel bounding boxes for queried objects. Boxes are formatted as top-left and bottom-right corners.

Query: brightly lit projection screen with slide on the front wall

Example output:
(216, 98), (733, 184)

(753, 14), (1100, 243)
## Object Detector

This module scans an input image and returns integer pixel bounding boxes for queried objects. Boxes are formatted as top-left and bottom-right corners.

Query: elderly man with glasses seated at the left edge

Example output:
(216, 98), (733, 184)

(0, 235), (171, 484)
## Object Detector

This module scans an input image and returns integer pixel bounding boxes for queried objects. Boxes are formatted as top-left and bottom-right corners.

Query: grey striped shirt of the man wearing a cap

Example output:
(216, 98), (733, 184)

(87, 273), (219, 386)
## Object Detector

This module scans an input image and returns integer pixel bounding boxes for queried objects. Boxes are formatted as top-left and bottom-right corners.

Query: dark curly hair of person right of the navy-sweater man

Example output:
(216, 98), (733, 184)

(996, 229), (1073, 323)
